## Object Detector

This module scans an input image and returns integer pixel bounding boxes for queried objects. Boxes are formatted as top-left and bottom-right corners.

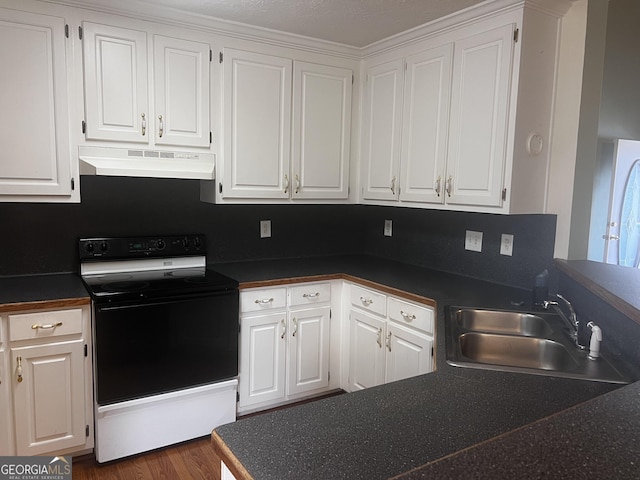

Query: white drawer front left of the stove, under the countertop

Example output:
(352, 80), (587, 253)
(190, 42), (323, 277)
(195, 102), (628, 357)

(9, 308), (82, 342)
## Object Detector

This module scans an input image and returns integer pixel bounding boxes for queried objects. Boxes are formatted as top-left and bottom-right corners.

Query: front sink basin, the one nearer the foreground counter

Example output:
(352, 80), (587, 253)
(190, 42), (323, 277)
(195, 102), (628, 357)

(459, 332), (578, 370)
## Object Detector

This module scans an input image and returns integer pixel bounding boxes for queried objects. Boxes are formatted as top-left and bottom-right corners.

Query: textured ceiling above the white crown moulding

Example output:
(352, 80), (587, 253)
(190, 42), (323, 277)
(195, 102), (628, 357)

(131, 0), (484, 47)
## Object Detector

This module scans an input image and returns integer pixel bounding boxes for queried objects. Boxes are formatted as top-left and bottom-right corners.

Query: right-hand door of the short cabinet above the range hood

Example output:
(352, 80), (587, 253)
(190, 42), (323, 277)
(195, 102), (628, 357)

(153, 35), (210, 147)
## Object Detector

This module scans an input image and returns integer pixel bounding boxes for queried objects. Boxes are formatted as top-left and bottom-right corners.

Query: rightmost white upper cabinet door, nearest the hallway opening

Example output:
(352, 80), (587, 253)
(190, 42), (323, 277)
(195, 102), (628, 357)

(445, 24), (514, 206)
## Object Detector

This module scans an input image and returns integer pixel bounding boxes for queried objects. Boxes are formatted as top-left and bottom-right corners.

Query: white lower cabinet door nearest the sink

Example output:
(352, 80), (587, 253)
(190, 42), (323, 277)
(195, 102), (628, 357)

(386, 322), (433, 382)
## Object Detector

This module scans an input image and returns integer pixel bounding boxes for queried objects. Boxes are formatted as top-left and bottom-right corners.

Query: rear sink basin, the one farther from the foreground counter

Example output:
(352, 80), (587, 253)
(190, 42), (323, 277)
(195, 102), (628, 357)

(455, 308), (552, 337)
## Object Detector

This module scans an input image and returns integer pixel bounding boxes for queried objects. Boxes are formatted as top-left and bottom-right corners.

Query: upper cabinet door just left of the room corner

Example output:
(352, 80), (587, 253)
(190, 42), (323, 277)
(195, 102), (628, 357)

(292, 62), (353, 199)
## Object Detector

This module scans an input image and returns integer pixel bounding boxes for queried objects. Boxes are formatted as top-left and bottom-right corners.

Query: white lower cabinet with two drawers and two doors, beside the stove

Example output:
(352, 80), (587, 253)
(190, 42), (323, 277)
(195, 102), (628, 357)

(238, 282), (331, 412)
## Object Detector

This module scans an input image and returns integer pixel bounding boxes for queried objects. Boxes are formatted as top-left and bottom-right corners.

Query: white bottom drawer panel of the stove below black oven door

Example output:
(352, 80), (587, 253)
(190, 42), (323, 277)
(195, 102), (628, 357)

(95, 379), (238, 463)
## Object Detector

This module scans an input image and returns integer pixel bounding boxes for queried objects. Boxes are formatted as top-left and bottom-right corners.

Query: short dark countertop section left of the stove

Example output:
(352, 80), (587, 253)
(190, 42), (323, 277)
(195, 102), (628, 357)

(0, 273), (91, 312)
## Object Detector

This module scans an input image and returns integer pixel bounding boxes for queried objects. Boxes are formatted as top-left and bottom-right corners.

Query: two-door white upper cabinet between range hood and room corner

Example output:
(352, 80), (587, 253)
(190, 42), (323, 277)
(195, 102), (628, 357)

(218, 48), (352, 200)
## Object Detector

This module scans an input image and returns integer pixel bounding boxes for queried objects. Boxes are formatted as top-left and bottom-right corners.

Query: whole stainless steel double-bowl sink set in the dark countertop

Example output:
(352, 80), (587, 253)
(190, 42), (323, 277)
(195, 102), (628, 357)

(445, 307), (629, 383)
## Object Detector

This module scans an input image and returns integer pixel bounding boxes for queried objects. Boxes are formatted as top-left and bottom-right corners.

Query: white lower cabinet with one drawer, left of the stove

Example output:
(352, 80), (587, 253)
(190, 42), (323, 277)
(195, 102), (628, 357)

(0, 305), (93, 455)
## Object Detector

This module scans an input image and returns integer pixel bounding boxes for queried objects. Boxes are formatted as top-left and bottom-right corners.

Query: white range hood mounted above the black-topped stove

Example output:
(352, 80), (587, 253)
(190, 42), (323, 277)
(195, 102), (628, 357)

(78, 146), (215, 180)
